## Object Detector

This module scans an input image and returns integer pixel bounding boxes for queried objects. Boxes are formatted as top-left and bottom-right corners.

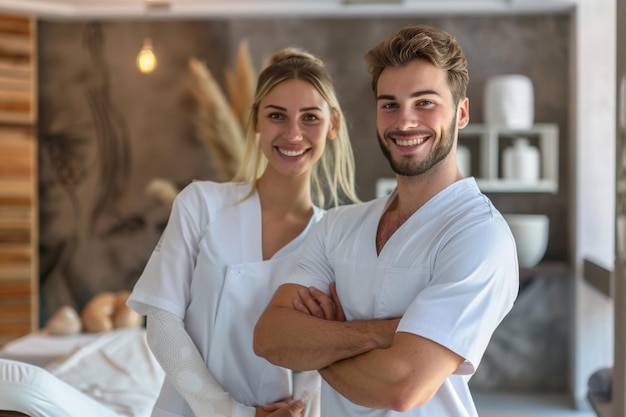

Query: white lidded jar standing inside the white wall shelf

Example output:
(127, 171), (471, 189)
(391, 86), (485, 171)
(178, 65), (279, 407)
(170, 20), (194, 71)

(502, 138), (539, 182)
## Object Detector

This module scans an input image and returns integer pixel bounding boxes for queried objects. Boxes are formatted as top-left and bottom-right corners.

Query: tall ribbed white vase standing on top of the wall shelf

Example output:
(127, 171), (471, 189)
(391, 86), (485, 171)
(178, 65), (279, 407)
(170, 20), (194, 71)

(483, 74), (535, 129)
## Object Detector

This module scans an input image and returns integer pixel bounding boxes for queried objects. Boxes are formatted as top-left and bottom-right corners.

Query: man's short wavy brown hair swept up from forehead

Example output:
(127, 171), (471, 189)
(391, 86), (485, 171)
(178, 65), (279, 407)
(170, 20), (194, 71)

(365, 25), (469, 103)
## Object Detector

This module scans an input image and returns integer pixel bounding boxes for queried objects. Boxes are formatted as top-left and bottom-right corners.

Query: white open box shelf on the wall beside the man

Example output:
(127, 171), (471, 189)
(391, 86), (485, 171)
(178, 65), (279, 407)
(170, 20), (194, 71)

(459, 123), (559, 193)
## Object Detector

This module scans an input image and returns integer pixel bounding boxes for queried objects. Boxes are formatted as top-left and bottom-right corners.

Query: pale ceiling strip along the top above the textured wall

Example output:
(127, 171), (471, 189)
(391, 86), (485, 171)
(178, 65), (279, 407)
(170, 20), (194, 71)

(0, 0), (578, 19)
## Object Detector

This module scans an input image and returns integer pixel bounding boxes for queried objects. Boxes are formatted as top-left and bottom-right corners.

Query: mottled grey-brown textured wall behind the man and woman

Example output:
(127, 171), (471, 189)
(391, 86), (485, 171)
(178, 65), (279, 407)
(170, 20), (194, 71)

(39, 15), (572, 390)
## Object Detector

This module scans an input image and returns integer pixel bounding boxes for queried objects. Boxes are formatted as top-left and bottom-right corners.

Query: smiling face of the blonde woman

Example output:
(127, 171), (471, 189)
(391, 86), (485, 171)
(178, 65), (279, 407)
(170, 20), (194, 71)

(256, 79), (337, 180)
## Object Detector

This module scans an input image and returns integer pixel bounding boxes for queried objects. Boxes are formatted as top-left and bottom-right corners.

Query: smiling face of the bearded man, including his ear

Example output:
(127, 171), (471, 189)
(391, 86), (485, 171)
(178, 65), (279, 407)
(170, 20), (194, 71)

(376, 60), (469, 176)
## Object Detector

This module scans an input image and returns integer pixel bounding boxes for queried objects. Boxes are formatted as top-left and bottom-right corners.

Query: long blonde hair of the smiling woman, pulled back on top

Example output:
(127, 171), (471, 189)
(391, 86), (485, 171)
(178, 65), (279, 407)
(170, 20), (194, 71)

(229, 47), (359, 207)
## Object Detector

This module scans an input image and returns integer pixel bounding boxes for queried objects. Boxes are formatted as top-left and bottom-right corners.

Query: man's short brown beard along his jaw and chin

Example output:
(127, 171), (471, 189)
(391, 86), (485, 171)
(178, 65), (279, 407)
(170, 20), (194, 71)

(376, 115), (457, 177)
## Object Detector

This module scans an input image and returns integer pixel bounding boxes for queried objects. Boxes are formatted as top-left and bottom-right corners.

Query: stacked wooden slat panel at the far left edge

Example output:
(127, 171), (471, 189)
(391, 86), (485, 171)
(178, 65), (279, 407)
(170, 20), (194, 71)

(0, 15), (39, 345)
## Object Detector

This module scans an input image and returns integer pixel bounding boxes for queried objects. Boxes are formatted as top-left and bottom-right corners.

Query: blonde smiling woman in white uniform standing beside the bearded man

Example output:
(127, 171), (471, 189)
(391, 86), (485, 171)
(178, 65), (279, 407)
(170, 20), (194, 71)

(128, 48), (357, 417)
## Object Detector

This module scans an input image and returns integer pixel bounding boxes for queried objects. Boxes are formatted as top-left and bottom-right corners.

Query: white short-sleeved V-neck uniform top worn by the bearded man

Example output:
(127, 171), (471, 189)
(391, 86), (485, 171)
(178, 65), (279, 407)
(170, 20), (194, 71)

(291, 178), (519, 417)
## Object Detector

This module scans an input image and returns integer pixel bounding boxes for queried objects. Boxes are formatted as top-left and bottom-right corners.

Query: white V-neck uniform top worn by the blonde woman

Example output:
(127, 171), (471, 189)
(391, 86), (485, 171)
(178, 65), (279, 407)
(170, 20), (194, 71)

(128, 181), (324, 417)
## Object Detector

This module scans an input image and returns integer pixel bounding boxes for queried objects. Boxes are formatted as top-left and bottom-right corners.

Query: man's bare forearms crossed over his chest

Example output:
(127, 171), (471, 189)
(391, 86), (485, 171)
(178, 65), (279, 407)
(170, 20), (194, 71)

(254, 284), (463, 412)
